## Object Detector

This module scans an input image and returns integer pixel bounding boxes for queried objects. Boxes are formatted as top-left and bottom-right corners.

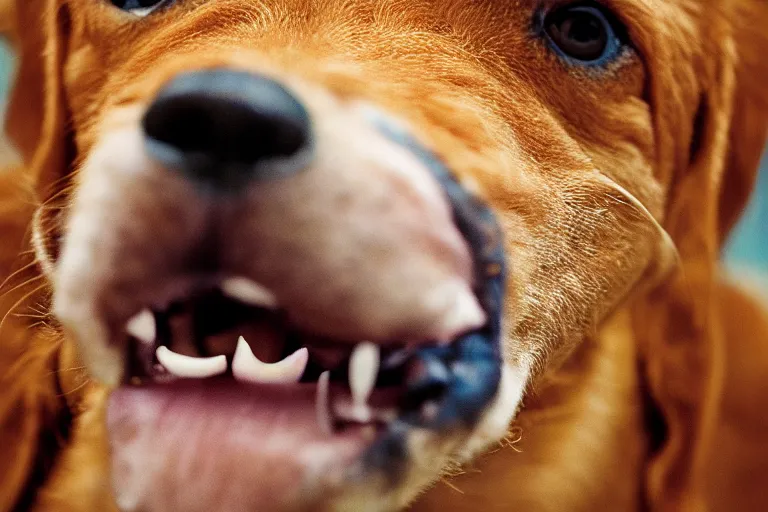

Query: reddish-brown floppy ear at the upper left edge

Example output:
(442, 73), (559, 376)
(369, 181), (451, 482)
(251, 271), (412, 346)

(0, 0), (71, 199)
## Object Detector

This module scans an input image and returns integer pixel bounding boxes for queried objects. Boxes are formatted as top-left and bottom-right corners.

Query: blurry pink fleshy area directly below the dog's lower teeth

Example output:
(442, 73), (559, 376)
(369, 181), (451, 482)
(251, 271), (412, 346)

(107, 381), (363, 512)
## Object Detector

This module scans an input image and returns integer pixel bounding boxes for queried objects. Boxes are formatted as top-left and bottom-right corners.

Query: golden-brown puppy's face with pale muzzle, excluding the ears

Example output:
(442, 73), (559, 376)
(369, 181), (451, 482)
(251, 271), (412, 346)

(9, 0), (760, 510)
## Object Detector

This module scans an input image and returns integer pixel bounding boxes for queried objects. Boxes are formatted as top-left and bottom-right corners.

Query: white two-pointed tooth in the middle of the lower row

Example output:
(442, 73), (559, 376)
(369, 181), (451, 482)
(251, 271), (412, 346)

(232, 336), (309, 384)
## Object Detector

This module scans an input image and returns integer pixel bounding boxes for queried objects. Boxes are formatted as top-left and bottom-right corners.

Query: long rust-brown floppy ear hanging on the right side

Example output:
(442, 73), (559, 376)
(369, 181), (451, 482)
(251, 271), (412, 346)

(634, 0), (768, 512)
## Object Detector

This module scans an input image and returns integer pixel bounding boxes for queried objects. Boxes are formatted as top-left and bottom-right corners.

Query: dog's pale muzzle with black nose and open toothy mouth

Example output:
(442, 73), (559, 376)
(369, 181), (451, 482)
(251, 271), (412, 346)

(54, 69), (505, 509)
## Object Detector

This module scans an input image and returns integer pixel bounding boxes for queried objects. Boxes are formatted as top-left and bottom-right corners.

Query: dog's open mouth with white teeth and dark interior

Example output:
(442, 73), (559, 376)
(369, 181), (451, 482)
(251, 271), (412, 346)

(125, 278), (440, 437)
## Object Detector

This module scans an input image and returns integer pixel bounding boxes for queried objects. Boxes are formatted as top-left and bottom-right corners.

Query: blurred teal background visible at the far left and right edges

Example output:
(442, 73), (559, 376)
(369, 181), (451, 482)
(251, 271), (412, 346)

(0, 43), (768, 275)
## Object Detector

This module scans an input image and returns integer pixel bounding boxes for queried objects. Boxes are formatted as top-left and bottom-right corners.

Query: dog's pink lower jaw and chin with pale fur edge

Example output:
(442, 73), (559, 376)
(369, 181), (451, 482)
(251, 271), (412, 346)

(108, 365), (528, 512)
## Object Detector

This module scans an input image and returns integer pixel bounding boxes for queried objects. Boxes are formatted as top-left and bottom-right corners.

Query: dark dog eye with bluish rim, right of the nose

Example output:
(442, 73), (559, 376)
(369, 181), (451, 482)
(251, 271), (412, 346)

(543, 3), (623, 65)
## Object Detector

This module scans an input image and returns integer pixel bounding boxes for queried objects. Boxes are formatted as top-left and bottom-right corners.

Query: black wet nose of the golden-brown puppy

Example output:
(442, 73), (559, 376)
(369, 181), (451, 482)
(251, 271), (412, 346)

(143, 70), (312, 189)
